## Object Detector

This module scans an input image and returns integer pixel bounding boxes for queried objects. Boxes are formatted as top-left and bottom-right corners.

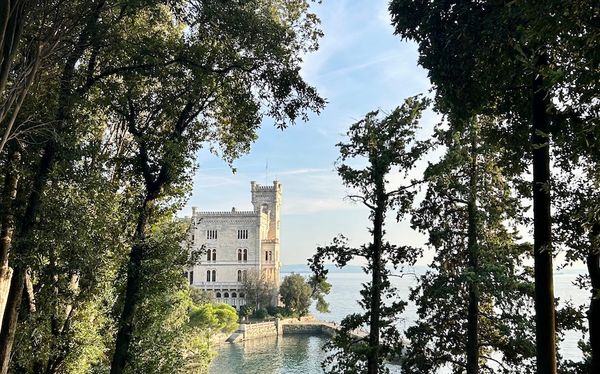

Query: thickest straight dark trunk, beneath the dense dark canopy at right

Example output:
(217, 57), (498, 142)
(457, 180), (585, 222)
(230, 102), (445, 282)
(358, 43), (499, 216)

(531, 53), (556, 374)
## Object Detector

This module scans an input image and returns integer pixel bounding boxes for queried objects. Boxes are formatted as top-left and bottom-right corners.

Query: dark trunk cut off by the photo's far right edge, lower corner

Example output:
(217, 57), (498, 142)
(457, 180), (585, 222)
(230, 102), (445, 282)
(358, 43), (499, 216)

(587, 223), (600, 374)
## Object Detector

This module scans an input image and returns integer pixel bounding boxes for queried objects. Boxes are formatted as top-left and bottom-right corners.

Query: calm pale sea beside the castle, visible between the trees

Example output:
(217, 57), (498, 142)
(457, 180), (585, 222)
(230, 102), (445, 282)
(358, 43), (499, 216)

(211, 270), (589, 374)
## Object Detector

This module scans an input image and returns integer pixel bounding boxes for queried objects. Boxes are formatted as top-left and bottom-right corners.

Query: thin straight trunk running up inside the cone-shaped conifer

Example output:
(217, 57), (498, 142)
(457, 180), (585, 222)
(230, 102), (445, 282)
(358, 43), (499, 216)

(467, 120), (479, 374)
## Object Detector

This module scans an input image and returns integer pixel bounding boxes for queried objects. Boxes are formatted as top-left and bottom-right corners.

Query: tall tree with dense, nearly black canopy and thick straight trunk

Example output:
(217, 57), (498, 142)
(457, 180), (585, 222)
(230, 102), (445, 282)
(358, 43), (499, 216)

(390, 0), (598, 373)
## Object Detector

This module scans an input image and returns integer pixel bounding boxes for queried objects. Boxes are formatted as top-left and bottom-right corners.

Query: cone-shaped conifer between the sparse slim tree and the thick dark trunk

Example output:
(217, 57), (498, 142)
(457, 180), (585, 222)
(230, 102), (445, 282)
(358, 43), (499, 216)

(402, 117), (535, 373)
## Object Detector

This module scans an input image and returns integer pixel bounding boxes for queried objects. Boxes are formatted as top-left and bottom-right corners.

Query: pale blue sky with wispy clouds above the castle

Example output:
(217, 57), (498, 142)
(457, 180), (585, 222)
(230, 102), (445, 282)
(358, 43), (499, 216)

(181, 0), (438, 265)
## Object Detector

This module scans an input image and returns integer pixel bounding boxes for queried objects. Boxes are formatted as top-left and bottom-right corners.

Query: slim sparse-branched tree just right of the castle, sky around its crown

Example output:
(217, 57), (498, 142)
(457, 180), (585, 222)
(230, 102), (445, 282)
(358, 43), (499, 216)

(309, 97), (428, 373)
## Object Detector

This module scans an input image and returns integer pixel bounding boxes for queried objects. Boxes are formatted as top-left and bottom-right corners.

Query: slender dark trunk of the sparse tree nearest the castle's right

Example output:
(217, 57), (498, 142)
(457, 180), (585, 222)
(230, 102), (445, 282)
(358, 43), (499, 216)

(367, 174), (386, 374)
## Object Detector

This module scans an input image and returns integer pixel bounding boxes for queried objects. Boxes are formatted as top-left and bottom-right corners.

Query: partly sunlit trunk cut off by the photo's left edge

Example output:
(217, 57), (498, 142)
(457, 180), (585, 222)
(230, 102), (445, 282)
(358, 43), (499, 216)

(0, 149), (21, 328)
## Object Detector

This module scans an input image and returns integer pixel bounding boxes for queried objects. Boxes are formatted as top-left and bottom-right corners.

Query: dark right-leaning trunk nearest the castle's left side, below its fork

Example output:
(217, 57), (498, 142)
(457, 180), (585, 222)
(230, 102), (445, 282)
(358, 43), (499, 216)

(110, 195), (154, 374)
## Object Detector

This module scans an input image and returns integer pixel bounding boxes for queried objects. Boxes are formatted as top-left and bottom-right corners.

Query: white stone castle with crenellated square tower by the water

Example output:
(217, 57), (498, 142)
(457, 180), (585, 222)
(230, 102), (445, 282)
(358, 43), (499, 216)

(186, 181), (281, 308)
